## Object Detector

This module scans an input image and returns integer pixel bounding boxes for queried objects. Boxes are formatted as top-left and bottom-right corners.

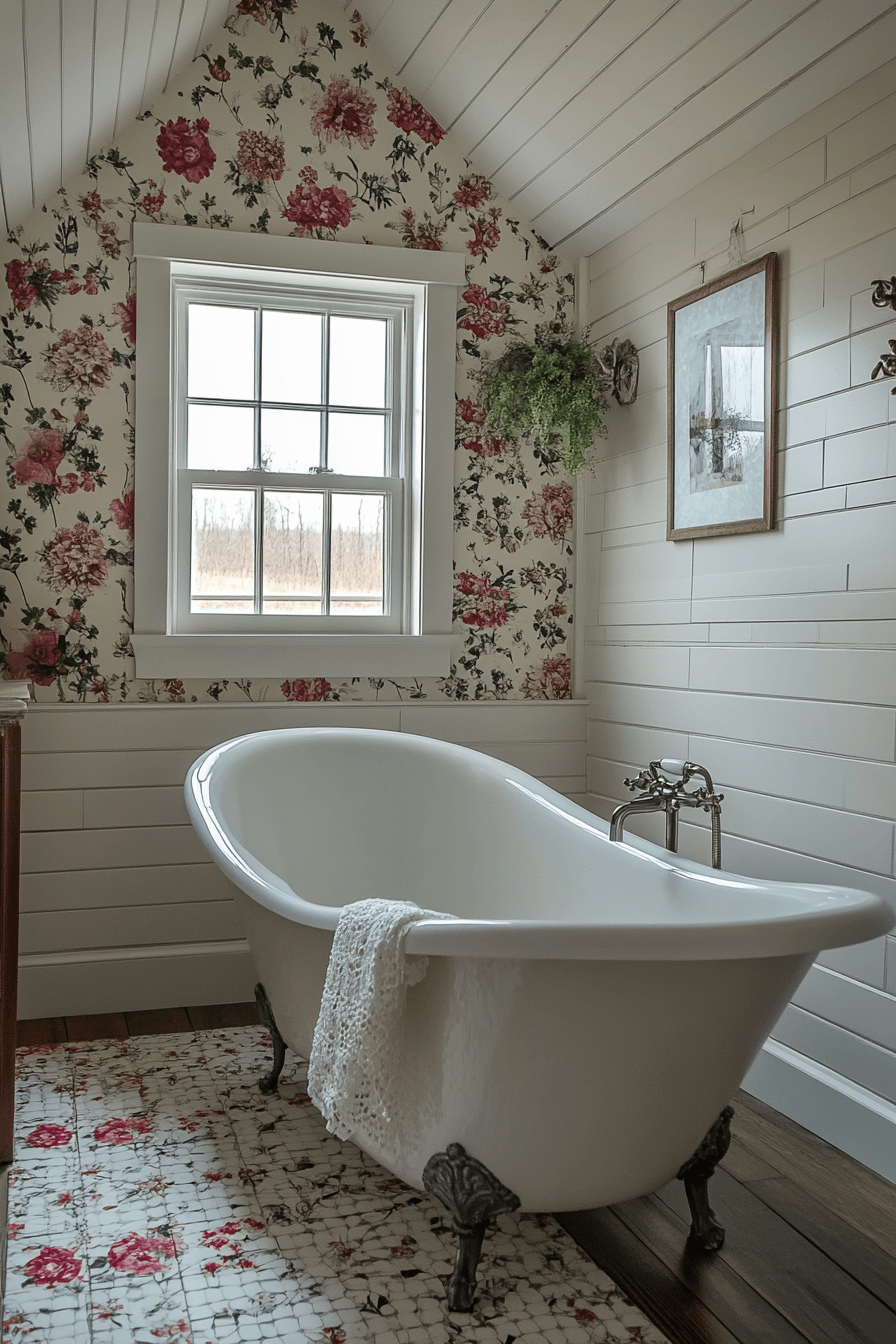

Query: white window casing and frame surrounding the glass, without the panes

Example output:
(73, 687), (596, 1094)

(132, 223), (465, 679)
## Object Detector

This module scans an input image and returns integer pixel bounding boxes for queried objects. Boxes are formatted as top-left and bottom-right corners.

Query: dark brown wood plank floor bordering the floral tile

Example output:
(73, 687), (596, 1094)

(19, 1004), (896, 1344)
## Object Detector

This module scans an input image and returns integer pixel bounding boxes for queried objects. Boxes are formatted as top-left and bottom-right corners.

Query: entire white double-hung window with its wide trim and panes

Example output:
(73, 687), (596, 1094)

(133, 224), (462, 677)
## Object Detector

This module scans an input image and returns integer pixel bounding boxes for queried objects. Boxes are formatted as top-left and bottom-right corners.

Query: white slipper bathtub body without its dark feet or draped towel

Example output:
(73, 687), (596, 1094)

(187, 728), (893, 1212)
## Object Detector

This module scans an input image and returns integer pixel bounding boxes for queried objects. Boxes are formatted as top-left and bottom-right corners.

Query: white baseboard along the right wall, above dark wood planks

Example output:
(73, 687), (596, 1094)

(743, 1039), (896, 1183)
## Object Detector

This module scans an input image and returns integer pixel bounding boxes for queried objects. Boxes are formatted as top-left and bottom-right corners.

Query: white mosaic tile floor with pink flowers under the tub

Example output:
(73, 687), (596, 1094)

(3, 1027), (665, 1344)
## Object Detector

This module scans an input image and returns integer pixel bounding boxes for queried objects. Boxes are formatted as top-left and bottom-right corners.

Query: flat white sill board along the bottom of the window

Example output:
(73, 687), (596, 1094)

(130, 634), (453, 680)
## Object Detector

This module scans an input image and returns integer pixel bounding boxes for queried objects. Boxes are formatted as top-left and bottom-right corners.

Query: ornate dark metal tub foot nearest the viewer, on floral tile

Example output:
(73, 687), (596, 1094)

(423, 1144), (520, 1312)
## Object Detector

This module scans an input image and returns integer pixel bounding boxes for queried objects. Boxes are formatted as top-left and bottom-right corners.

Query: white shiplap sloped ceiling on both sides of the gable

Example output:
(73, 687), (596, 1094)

(0, 0), (896, 258)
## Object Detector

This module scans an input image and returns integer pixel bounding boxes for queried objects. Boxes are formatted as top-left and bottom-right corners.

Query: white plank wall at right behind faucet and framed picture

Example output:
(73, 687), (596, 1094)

(580, 62), (896, 1180)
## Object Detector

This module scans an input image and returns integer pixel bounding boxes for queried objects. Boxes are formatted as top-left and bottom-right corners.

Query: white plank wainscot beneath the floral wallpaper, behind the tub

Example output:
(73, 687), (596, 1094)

(19, 700), (586, 1017)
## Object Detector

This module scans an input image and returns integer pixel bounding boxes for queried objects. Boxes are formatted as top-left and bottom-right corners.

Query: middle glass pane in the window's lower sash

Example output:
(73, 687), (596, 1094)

(265, 491), (324, 599)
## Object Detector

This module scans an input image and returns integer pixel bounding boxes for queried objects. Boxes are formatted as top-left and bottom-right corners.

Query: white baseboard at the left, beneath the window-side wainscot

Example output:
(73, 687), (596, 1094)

(19, 938), (258, 1019)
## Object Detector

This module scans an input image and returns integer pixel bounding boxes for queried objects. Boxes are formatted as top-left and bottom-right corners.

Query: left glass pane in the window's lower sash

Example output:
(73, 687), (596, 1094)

(191, 488), (255, 599)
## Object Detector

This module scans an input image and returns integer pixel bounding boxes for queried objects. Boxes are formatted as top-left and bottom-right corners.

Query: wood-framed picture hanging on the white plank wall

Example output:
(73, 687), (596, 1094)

(666, 253), (778, 542)
